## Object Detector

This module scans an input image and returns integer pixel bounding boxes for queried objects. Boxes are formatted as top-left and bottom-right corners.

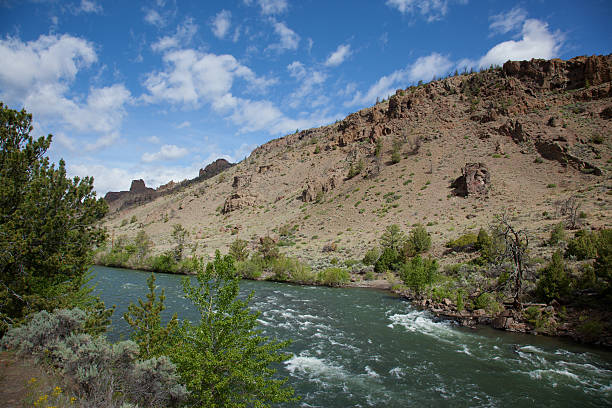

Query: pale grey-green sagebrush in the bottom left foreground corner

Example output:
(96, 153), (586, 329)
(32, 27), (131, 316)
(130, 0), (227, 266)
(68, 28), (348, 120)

(2, 309), (187, 407)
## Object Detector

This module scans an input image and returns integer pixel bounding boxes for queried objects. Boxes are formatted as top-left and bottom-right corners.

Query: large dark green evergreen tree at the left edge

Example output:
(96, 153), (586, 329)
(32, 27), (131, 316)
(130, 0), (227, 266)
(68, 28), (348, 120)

(0, 103), (108, 333)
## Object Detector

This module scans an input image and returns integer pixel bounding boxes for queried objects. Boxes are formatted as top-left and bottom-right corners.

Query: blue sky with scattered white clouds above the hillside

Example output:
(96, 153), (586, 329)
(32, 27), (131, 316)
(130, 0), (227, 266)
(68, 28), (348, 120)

(0, 0), (612, 194)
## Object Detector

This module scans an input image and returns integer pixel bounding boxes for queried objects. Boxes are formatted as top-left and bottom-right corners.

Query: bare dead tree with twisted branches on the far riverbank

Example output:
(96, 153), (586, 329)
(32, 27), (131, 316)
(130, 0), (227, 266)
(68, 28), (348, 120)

(497, 214), (529, 310)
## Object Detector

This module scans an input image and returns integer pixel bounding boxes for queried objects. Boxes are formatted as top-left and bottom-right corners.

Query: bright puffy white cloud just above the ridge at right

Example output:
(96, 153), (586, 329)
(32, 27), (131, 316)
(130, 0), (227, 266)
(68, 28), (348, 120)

(478, 19), (563, 67)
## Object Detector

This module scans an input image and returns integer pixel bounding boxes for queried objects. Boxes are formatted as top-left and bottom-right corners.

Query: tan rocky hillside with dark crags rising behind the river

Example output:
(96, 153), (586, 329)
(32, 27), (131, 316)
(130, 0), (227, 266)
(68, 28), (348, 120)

(106, 55), (612, 262)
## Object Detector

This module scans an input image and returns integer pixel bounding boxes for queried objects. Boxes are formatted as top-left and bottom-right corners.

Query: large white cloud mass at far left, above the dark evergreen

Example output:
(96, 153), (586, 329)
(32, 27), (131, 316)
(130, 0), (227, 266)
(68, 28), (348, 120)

(0, 34), (132, 150)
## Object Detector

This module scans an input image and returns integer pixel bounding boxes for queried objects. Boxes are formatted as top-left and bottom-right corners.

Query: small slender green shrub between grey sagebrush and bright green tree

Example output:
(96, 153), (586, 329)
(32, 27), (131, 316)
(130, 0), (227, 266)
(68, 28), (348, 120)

(123, 273), (178, 358)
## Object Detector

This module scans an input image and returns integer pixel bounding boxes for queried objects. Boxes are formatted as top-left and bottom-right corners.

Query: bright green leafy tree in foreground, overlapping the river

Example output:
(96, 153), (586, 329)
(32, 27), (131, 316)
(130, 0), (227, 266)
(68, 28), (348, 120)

(168, 251), (294, 407)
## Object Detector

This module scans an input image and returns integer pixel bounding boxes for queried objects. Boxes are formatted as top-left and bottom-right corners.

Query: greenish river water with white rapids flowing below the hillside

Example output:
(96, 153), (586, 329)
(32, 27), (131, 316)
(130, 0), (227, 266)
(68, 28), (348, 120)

(93, 266), (612, 408)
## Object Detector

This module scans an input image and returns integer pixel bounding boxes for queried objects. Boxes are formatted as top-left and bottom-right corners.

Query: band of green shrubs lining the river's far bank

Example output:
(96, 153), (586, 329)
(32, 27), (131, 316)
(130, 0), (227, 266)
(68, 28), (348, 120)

(95, 220), (612, 347)
